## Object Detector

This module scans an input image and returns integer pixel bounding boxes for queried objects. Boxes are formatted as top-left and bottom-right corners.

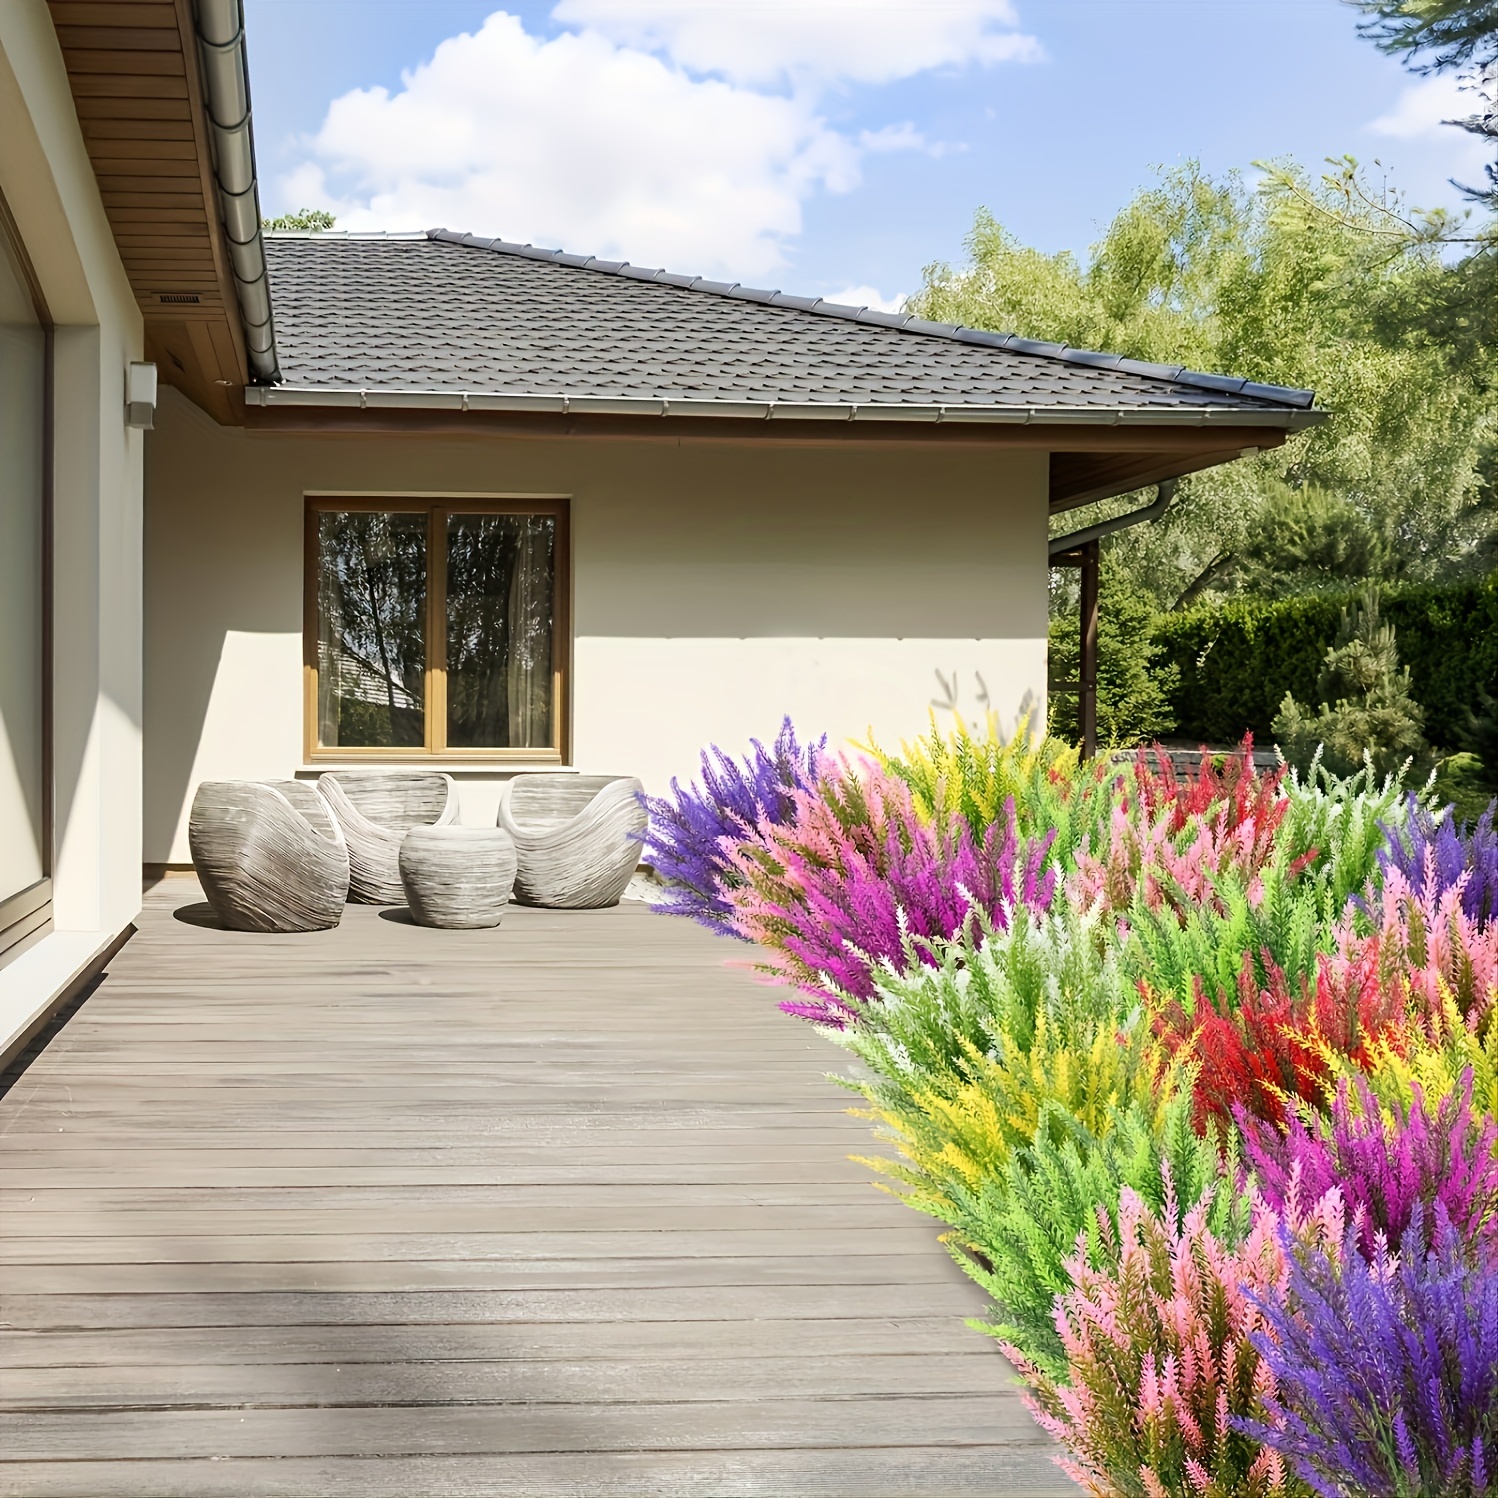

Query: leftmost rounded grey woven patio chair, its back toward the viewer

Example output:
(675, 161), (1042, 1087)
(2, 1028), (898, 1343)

(187, 780), (349, 932)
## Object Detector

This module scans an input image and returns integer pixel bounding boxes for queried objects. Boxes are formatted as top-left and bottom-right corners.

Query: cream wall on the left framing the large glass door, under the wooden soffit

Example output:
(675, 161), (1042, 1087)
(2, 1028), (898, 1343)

(0, 0), (142, 946)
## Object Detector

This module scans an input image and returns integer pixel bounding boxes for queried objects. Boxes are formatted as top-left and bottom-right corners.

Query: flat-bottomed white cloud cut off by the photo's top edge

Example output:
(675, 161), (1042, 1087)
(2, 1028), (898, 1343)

(553, 0), (1040, 84)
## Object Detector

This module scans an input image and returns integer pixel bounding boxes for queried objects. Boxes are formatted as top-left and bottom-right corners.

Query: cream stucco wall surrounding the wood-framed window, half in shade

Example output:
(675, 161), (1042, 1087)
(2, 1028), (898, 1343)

(145, 391), (1047, 863)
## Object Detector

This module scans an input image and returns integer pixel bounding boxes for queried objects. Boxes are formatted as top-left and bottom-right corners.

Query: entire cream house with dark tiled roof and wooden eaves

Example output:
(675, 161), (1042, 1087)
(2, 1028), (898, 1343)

(0, 0), (1320, 1044)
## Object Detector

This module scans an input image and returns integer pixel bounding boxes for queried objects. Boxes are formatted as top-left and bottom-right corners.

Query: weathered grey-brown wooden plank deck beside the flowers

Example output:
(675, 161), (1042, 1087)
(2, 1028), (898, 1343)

(0, 881), (1076, 1498)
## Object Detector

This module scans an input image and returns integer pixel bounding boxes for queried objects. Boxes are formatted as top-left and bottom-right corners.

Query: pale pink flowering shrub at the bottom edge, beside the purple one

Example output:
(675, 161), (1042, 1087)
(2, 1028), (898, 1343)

(1011, 1189), (1335, 1498)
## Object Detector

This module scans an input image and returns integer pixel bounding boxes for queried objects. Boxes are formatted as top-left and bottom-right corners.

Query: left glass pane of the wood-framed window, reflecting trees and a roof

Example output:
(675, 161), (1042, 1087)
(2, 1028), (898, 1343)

(318, 511), (427, 749)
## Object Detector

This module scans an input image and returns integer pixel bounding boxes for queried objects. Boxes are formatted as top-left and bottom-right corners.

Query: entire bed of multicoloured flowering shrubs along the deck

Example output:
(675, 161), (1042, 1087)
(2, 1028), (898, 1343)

(650, 724), (1498, 1498)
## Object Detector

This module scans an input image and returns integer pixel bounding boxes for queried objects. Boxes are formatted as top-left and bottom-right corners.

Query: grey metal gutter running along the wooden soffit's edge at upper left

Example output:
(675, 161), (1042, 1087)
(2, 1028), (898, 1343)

(195, 0), (280, 383)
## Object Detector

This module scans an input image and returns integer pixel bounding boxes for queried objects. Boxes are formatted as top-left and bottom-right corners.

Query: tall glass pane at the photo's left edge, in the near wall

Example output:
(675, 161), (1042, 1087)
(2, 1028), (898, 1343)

(0, 223), (46, 900)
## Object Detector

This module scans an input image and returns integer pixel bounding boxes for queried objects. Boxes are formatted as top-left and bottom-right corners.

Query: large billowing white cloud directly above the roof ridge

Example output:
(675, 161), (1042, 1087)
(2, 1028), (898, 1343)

(282, 12), (858, 277)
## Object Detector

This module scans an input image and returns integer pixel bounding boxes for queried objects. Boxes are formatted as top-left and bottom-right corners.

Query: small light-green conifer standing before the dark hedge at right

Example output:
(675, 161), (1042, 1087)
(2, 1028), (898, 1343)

(1273, 587), (1426, 774)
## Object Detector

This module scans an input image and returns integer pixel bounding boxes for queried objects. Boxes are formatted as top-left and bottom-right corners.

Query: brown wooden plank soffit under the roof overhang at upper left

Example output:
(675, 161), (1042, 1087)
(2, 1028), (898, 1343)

(48, 0), (249, 422)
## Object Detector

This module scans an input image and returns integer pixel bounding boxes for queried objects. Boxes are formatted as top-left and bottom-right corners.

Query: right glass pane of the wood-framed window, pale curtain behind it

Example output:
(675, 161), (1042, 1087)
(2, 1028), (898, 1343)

(446, 514), (556, 749)
